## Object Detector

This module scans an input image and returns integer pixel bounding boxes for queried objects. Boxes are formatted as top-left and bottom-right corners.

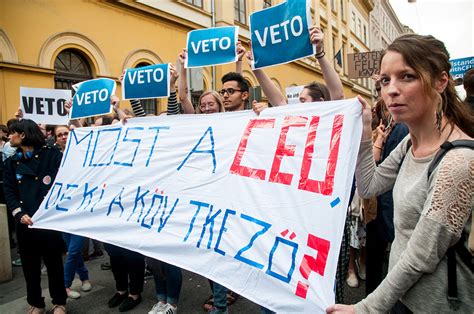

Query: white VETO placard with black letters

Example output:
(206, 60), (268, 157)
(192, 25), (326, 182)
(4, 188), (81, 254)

(20, 87), (71, 125)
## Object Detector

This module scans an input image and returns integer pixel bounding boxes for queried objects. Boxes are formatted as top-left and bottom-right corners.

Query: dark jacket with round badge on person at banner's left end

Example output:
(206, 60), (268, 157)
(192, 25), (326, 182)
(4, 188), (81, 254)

(3, 146), (62, 221)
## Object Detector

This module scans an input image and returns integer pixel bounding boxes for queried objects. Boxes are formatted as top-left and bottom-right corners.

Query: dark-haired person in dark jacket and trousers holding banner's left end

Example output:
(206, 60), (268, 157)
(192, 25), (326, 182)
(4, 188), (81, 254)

(4, 119), (67, 314)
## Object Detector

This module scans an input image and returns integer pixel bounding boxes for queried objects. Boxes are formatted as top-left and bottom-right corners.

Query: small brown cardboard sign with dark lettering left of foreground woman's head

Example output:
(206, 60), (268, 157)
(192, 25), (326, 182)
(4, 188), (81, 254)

(347, 51), (382, 79)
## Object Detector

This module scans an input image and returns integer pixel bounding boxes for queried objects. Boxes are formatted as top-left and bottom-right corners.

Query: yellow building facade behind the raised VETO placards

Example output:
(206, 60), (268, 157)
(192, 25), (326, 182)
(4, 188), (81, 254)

(0, 0), (374, 123)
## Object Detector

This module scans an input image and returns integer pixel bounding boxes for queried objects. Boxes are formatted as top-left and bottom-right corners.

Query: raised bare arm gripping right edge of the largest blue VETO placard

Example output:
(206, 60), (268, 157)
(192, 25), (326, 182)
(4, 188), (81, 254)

(309, 26), (344, 100)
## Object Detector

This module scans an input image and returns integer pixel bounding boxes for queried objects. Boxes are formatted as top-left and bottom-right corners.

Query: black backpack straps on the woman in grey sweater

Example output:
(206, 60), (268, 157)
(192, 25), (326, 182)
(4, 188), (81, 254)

(402, 140), (474, 310)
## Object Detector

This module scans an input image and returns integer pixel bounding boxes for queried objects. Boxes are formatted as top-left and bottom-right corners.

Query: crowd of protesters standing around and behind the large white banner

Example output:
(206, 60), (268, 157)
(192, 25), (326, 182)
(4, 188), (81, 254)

(0, 27), (474, 314)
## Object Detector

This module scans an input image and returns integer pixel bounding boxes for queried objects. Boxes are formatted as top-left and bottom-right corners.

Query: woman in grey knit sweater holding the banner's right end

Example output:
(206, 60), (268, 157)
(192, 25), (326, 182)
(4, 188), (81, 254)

(326, 34), (474, 313)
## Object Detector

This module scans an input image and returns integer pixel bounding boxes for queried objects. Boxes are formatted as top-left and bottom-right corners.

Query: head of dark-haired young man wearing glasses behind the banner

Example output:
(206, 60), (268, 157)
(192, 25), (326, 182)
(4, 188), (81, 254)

(219, 72), (249, 111)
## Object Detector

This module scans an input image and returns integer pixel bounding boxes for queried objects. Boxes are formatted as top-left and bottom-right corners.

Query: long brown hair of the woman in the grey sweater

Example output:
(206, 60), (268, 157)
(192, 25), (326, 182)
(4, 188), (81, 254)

(380, 34), (474, 137)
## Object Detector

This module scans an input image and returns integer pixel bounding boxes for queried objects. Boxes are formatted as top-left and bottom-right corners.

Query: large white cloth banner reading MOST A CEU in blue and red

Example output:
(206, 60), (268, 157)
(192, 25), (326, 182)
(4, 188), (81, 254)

(33, 99), (362, 313)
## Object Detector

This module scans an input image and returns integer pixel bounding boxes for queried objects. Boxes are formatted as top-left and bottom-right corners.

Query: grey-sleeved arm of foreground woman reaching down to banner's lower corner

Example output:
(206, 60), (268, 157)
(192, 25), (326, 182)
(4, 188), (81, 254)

(355, 149), (474, 313)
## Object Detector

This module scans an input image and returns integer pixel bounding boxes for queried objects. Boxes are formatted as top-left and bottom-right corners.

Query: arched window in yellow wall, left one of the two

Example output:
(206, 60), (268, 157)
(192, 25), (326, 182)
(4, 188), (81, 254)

(54, 49), (93, 90)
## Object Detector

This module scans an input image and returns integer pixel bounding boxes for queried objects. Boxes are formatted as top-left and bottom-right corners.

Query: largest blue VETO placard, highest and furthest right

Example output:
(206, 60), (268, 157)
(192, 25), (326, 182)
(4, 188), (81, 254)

(250, 0), (316, 69)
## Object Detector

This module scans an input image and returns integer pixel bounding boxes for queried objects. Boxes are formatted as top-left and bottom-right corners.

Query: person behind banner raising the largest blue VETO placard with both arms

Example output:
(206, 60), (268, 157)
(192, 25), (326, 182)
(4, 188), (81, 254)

(250, 26), (344, 112)
